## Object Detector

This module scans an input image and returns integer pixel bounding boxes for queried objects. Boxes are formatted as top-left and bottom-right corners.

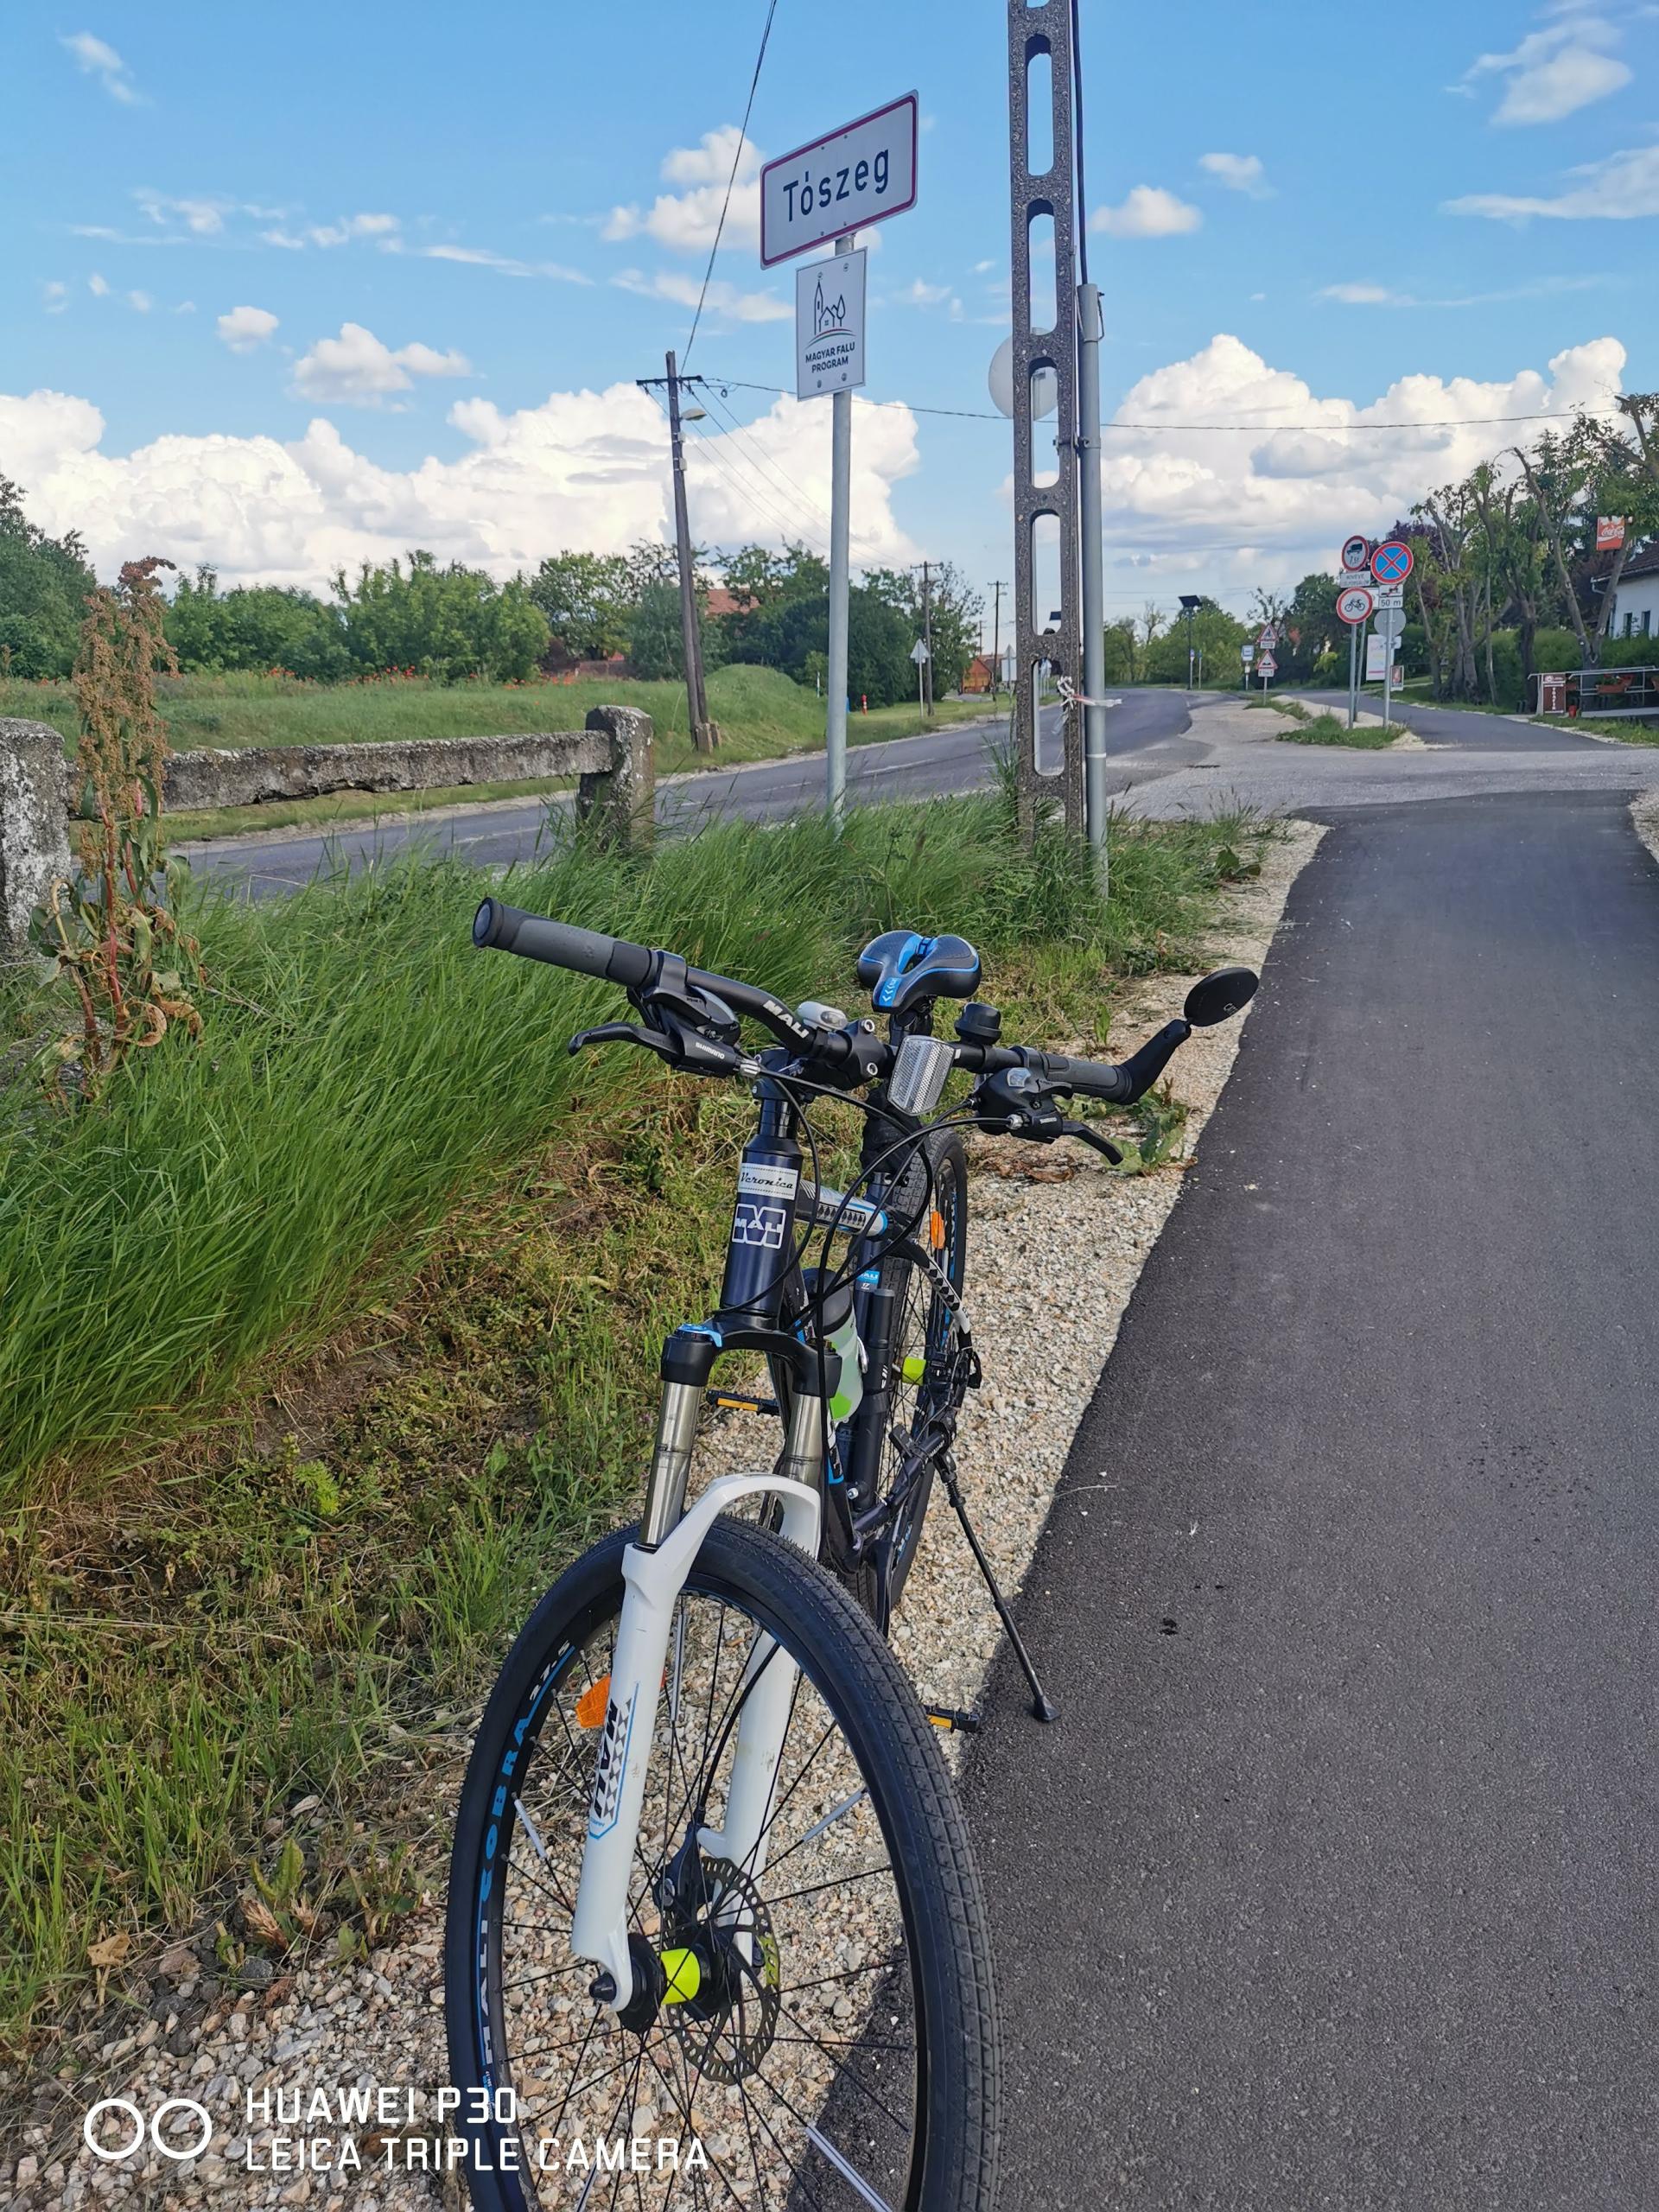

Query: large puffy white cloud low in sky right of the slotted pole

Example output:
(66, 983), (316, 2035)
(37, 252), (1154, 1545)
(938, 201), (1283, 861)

(1084, 336), (1626, 588)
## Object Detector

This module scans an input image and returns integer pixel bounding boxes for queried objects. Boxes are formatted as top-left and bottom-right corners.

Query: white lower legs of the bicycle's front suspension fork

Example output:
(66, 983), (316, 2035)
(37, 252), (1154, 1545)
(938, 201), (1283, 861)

(570, 1476), (823, 2011)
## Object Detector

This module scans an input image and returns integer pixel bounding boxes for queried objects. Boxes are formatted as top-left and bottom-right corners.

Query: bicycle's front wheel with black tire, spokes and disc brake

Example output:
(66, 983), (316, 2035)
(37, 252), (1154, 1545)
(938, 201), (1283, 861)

(447, 1520), (998, 2212)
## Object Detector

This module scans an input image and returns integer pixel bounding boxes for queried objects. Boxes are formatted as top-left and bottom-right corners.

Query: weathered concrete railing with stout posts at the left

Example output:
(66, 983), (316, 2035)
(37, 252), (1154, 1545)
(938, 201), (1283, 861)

(0, 706), (657, 960)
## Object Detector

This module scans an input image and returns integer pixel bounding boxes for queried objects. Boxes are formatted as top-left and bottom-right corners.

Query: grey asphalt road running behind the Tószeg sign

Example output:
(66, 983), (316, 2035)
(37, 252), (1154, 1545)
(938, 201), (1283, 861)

(190, 690), (1204, 898)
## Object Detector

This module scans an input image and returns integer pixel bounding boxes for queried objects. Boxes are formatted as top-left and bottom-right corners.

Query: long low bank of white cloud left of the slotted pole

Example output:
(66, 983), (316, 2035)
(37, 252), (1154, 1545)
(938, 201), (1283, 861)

(0, 383), (918, 588)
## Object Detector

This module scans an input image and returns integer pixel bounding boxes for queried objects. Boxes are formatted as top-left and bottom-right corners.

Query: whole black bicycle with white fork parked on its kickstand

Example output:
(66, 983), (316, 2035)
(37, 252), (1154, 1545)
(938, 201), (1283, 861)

(445, 898), (1256, 2212)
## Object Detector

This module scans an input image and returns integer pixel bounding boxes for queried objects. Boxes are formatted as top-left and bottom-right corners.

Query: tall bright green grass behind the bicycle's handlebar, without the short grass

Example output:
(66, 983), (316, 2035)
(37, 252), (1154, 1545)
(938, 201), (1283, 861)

(0, 797), (1247, 1506)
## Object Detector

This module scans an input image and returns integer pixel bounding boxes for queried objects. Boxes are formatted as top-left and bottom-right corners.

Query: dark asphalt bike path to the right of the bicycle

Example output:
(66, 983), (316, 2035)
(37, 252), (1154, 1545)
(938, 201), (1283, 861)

(967, 791), (1659, 2212)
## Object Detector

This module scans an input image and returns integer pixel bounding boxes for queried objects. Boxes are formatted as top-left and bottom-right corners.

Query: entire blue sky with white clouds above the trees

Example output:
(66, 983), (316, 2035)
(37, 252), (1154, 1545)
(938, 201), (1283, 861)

(0, 0), (1659, 611)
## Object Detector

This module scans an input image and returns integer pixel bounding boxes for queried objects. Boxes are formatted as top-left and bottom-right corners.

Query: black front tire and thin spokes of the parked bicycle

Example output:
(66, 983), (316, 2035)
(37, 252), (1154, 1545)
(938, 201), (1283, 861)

(445, 1517), (998, 2212)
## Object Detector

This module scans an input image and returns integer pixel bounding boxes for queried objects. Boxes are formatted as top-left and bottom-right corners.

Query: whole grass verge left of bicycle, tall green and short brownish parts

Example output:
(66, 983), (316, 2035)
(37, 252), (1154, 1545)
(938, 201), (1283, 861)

(0, 794), (1252, 2046)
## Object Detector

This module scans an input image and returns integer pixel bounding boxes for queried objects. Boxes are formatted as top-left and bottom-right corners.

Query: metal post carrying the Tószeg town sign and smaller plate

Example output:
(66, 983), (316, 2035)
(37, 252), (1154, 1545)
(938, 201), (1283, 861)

(761, 93), (918, 827)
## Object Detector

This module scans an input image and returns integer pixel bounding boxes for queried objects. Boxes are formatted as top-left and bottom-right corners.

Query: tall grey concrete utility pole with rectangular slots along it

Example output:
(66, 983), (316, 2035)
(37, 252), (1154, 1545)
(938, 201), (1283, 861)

(1008, 0), (1084, 836)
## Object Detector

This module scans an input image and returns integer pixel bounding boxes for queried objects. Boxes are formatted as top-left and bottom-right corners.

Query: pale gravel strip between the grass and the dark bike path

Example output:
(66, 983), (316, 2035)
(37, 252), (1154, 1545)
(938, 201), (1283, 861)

(0, 823), (1327, 2212)
